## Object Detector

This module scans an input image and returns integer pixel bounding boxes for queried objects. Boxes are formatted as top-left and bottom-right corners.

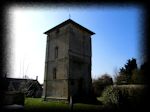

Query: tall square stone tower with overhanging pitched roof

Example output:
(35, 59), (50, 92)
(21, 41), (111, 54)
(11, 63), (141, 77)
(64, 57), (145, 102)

(43, 19), (94, 100)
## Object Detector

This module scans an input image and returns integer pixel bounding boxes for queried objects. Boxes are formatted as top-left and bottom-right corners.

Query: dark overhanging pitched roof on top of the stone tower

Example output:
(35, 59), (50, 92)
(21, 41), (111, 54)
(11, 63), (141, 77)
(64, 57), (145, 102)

(44, 19), (95, 35)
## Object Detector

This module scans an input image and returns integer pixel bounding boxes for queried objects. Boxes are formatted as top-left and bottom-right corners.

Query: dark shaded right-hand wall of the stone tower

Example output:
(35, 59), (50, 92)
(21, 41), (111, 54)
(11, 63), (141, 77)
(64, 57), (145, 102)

(69, 25), (91, 95)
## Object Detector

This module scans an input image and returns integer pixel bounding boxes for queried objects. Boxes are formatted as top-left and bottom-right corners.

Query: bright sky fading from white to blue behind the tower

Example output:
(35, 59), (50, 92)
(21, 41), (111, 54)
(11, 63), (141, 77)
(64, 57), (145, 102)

(7, 5), (142, 84)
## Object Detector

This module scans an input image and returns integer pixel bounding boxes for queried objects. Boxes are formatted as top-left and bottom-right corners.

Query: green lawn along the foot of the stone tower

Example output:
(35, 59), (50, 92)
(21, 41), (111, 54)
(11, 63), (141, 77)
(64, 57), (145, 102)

(25, 98), (108, 112)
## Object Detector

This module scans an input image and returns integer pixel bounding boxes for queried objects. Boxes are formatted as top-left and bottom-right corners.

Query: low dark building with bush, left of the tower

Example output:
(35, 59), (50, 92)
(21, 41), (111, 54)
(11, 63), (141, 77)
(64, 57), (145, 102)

(4, 78), (43, 97)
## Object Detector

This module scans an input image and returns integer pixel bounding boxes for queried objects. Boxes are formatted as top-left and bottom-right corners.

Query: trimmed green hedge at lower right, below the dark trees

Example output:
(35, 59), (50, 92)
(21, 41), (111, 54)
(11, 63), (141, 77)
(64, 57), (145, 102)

(101, 85), (146, 107)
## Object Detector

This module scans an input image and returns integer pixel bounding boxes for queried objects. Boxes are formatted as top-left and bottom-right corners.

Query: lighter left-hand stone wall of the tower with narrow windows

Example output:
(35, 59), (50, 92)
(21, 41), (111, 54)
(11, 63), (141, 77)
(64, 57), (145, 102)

(43, 26), (69, 98)
